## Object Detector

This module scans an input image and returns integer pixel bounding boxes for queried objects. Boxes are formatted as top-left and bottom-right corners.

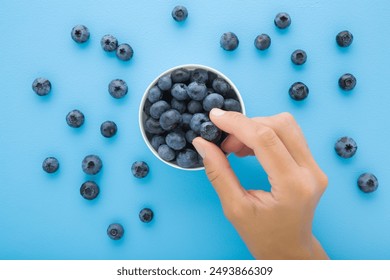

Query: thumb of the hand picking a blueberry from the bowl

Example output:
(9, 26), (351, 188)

(192, 137), (246, 211)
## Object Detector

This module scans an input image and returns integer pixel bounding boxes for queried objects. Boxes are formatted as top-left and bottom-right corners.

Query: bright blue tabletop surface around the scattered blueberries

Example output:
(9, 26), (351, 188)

(0, 0), (390, 259)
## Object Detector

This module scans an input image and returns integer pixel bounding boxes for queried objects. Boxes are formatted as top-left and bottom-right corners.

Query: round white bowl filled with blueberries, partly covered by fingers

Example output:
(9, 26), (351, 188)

(139, 64), (245, 170)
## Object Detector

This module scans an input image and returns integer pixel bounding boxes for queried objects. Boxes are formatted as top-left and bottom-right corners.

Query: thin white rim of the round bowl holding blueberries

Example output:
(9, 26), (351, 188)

(138, 64), (245, 171)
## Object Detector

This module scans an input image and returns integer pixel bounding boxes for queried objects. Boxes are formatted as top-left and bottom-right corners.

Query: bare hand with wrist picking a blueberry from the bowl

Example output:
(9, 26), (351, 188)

(193, 109), (328, 259)
